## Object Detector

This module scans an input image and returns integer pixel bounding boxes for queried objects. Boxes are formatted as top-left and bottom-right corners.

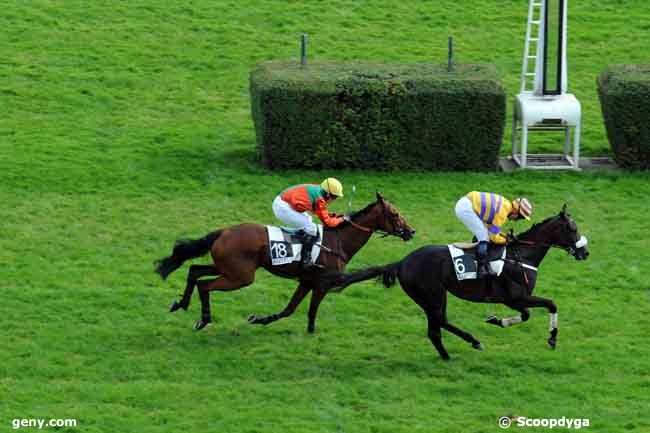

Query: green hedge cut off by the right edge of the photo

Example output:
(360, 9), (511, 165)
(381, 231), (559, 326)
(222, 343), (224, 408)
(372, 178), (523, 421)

(598, 65), (650, 170)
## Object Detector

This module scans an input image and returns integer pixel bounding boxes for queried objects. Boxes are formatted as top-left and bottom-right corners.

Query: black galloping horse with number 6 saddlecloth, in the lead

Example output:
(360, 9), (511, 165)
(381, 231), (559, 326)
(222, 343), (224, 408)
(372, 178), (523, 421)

(321, 204), (589, 360)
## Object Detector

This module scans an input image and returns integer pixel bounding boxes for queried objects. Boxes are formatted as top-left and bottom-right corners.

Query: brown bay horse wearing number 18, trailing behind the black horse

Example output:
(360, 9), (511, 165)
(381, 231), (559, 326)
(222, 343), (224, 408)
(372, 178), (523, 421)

(155, 193), (415, 333)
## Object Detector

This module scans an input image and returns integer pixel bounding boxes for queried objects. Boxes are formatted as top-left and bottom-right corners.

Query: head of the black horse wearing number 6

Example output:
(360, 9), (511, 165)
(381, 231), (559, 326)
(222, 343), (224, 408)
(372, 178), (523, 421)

(520, 204), (589, 260)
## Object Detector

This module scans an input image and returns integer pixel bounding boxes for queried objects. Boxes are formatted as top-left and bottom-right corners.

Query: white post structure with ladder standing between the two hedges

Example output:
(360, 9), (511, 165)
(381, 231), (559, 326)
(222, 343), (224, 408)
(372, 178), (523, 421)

(512, 0), (582, 170)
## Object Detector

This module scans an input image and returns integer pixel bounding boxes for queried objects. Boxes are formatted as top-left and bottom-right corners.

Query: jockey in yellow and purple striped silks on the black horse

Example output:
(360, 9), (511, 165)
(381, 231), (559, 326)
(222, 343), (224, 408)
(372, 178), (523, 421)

(456, 191), (533, 278)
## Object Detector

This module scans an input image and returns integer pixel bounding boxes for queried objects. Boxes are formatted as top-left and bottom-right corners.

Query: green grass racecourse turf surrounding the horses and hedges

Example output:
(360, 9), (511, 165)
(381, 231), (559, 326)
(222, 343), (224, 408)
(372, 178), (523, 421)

(0, 0), (650, 433)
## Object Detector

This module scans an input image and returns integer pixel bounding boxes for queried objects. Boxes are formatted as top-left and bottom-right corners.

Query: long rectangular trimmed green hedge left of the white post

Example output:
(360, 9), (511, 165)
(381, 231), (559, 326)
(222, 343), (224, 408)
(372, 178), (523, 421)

(250, 61), (506, 170)
